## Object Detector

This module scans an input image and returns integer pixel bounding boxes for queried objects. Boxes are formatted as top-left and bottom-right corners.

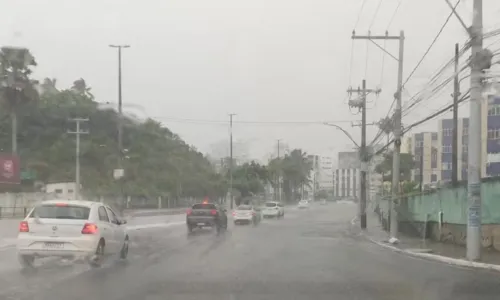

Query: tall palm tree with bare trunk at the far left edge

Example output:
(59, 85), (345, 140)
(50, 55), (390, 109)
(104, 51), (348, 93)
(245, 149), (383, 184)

(0, 47), (39, 153)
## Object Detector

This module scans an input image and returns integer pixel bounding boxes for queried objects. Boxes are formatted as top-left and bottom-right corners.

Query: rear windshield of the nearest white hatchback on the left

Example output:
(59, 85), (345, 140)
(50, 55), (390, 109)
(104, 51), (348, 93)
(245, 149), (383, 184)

(30, 204), (90, 220)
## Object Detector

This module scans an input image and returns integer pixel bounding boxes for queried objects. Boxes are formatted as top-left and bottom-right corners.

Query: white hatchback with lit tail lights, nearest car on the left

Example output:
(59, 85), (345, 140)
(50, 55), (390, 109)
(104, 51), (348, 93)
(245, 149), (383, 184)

(17, 200), (129, 267)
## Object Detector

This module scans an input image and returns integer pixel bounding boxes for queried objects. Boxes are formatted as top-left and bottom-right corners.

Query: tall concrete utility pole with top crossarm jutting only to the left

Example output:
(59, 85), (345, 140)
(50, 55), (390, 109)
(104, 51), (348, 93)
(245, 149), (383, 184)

(352, 31), (405, 240)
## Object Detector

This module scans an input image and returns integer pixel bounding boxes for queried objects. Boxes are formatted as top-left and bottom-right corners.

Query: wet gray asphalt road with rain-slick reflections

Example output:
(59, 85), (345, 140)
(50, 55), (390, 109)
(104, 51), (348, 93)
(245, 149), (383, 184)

(0, 204), (500, 300)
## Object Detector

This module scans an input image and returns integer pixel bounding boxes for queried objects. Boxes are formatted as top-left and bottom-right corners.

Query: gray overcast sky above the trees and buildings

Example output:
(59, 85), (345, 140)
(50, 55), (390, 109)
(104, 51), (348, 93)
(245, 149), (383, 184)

(0, 0), (500, 163)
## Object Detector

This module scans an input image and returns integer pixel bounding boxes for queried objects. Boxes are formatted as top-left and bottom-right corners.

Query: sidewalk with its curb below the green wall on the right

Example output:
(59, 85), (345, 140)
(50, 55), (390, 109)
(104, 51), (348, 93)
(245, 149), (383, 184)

(363, 212), (500, 271)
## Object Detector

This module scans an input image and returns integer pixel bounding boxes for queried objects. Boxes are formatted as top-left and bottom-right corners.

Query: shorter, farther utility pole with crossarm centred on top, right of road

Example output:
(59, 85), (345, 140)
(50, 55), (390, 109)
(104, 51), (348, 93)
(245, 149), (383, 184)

(347, 79), (380, 229)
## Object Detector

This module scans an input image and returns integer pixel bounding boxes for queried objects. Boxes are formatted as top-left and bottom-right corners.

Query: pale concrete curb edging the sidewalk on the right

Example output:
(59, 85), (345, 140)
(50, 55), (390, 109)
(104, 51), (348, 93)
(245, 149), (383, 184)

(362, 233), (500, 272)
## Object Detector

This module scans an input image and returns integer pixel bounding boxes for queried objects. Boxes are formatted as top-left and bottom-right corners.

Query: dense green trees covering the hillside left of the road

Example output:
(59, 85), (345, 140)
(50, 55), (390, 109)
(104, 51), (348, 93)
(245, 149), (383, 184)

(0, 48), (312, 203)
